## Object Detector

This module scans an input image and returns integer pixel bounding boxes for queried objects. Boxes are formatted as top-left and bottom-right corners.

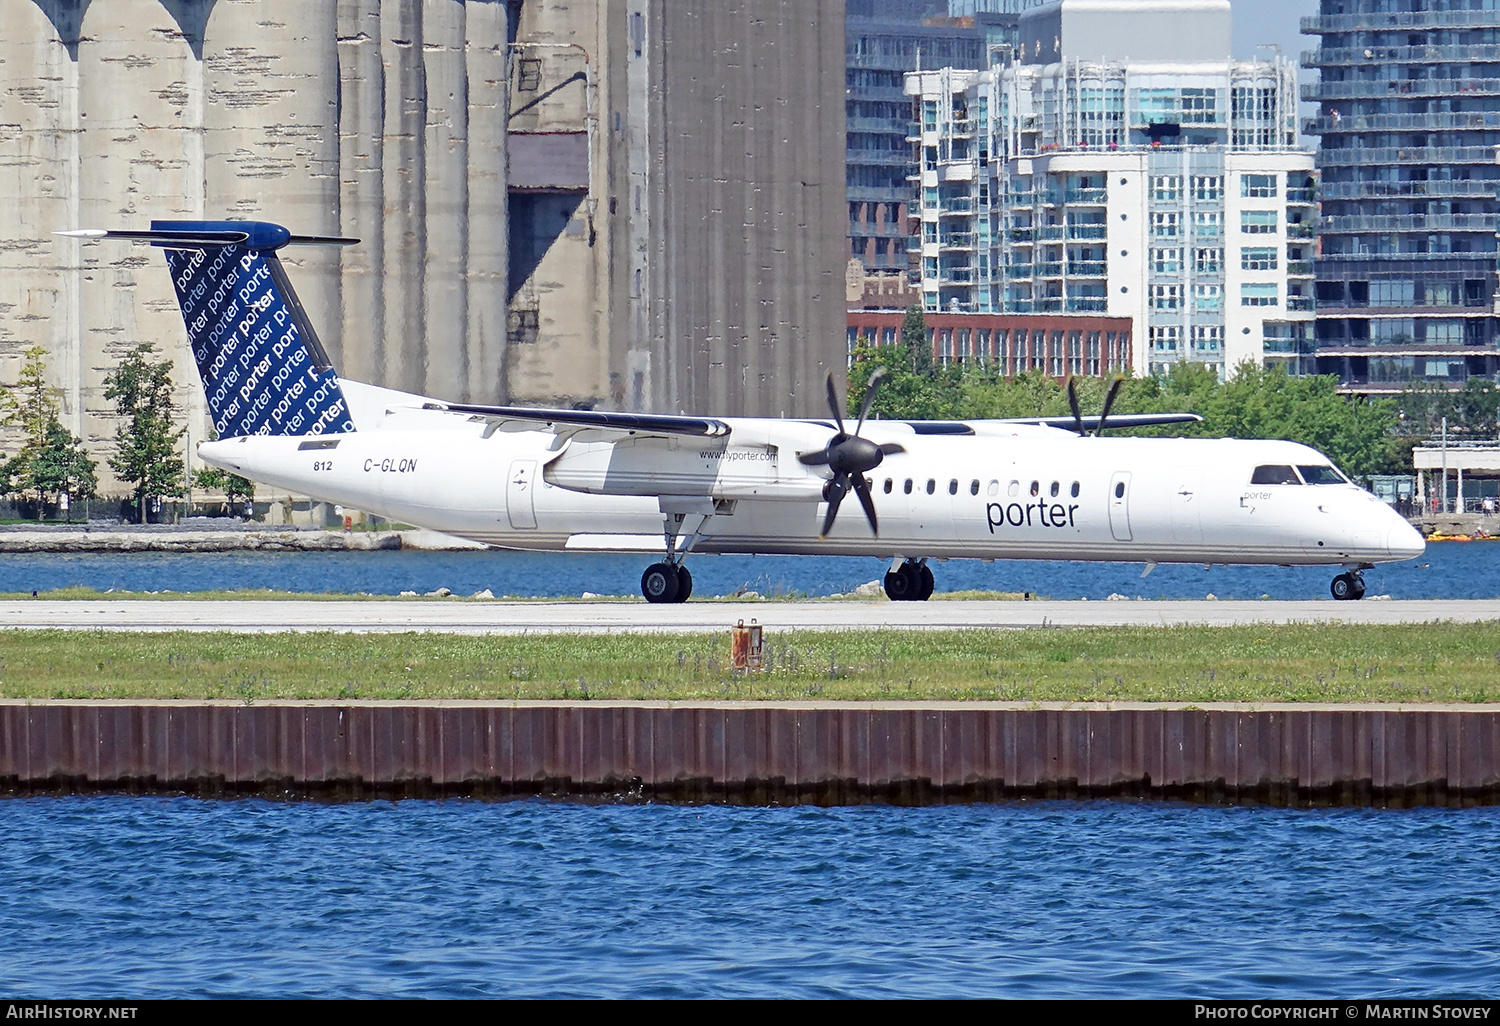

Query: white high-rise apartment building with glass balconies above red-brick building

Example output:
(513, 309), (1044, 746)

(908, 0), (1314, 375)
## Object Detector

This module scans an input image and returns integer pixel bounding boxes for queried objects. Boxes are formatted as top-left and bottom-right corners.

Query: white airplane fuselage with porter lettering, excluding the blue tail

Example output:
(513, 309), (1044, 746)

(200, 414), (1422, 566)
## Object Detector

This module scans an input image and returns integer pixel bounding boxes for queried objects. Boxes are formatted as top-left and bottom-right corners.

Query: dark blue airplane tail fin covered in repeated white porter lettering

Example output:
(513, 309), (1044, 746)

(80, 221), (357, 438)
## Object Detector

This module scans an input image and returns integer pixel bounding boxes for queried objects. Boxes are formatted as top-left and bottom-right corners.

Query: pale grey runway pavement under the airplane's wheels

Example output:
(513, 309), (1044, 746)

(0, 600), (1500, 635)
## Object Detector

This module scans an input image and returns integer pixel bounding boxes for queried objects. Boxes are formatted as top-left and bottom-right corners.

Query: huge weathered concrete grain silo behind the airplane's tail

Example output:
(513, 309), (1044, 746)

(0, 0), (845, 498)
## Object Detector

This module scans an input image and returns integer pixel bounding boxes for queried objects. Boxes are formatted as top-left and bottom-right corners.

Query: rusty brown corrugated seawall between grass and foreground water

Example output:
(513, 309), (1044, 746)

(0, 701), (1500, 806)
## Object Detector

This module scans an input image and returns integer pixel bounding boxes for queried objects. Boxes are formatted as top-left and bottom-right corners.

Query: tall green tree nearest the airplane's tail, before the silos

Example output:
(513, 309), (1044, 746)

(104, 342), (188, 524)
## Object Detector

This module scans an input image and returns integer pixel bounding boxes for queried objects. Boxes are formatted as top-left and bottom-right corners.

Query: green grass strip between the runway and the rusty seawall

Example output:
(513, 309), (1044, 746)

(0, 623), (1500, 702)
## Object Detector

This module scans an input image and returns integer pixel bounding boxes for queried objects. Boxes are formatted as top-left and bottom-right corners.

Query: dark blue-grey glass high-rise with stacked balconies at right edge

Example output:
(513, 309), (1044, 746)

(1302, 0), (1500, 392)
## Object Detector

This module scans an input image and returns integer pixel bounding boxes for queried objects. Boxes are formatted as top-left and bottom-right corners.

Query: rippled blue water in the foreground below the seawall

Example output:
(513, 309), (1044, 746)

(0, 797), (1500, 999)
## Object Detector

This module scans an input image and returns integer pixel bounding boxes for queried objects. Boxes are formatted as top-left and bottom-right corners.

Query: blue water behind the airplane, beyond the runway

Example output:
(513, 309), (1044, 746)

(0, 542), (1500, 600)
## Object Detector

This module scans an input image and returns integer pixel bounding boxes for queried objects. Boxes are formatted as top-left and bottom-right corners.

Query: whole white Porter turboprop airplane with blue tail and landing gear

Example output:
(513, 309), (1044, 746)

(60, 221), (1425, 602)
